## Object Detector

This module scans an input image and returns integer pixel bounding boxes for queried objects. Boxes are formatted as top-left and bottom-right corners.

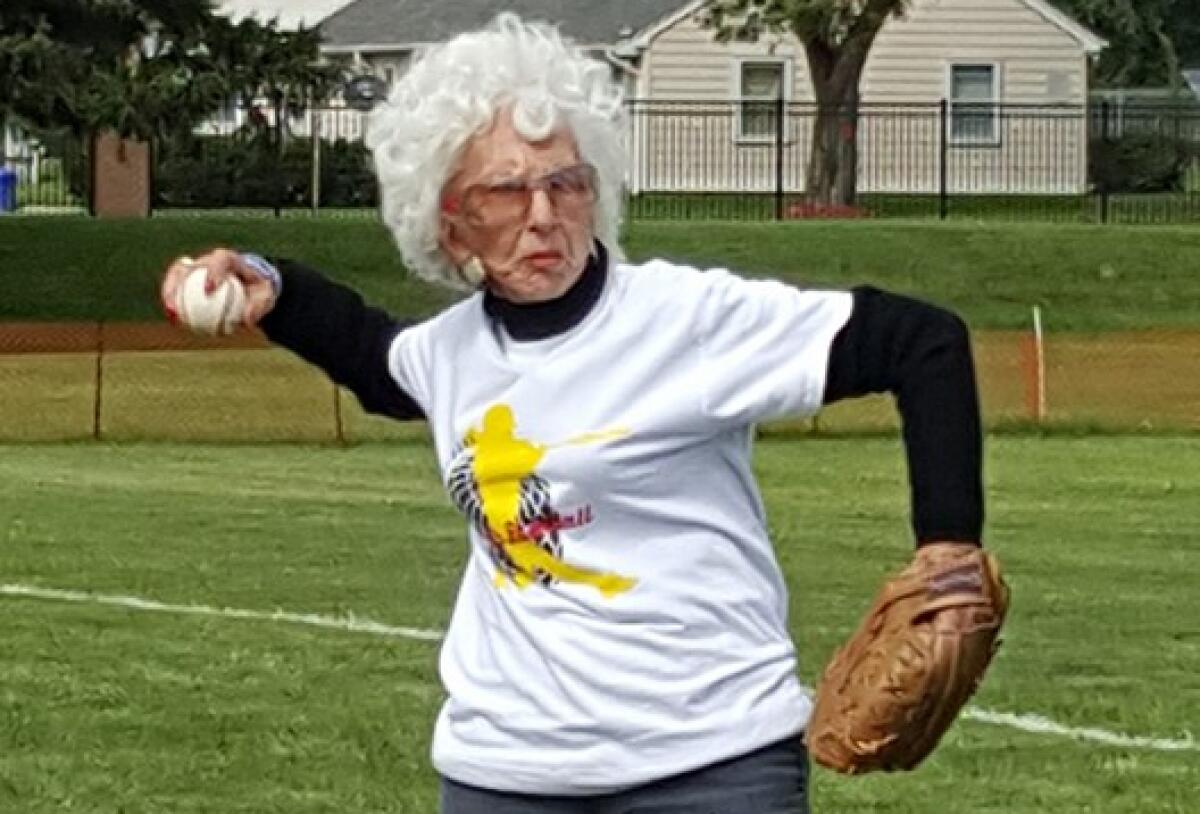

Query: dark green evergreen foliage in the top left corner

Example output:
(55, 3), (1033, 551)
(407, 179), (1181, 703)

(0, 0), (340, 138)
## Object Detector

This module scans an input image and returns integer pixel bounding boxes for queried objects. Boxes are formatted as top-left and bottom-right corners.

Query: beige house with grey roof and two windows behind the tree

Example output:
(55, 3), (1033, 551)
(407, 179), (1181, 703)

(320, 0), (1106, 193)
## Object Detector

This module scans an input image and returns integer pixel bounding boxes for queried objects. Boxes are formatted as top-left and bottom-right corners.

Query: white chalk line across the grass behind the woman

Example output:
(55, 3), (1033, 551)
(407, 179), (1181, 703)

(0, 585), (1200, 752)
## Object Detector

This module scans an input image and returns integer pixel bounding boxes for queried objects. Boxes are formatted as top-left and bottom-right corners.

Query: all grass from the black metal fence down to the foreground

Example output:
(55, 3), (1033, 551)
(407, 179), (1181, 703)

(0, 216), (1200, 814)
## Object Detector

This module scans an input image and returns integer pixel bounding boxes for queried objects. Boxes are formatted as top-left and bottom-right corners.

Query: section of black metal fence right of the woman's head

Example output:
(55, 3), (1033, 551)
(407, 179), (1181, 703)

(629, 101), (1200, 222)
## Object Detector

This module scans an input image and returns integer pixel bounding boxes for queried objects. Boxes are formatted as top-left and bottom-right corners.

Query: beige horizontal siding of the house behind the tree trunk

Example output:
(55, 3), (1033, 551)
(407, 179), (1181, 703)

(631, 0), (1087, 193)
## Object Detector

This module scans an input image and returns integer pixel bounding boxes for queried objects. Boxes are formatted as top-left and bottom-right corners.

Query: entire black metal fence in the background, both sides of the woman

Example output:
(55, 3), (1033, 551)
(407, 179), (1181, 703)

(9, 100), (1200, 223)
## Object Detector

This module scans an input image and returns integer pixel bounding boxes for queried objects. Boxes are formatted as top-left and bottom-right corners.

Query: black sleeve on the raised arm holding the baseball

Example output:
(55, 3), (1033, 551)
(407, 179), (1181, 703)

(259, 258), (425, 420)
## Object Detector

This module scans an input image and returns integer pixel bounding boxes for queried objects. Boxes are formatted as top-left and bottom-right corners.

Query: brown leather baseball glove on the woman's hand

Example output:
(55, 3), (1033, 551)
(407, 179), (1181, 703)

(805, 543), (1008, 774)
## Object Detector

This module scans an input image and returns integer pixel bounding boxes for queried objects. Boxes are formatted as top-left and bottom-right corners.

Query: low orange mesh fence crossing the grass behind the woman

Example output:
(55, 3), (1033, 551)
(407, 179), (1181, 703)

(0, 323), (1200, 443)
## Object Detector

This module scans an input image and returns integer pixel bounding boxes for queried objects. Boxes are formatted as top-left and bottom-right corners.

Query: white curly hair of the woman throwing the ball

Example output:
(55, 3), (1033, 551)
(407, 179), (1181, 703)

(366, 13), (626, 289)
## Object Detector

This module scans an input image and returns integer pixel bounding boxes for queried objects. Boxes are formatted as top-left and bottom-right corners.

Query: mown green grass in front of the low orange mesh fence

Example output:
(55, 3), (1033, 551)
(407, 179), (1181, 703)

(0, 437), (1200, 814)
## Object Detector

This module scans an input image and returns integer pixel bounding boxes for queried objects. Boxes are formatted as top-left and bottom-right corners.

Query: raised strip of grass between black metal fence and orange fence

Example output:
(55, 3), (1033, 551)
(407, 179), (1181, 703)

(0, 216), (1200, 331)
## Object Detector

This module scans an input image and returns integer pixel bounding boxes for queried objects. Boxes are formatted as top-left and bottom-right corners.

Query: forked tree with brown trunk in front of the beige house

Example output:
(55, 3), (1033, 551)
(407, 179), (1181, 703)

(704, 0), (907, 205)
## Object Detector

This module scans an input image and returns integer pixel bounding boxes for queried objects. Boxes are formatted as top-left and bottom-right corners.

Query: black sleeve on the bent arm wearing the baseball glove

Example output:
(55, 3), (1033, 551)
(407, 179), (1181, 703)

(824, 287), (984, 545)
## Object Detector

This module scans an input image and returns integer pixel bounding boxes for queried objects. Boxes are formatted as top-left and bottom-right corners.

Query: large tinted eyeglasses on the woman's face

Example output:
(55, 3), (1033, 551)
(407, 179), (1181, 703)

(442, 163), (596, 227)
